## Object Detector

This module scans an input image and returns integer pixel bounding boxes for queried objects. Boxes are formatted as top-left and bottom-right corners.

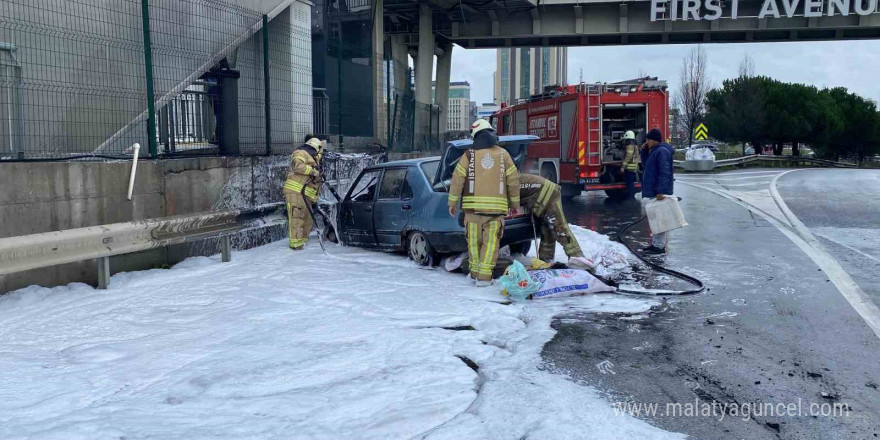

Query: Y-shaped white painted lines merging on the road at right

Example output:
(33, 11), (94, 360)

(682, 174), (880, 338)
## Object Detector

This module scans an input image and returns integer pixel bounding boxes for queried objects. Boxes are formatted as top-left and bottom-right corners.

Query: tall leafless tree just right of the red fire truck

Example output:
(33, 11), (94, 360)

(675, 46), (711, 147)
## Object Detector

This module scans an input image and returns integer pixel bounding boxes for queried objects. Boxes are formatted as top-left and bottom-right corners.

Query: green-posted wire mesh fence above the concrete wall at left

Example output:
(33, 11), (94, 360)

(0, 0), (314, 160)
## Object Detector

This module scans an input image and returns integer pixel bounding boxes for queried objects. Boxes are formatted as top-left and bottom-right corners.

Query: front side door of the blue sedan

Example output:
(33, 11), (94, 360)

(339, 170), (382, 247)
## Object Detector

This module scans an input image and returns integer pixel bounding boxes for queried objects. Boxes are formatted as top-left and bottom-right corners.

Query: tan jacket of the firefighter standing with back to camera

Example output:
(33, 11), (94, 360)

(449, 138), (520, 215)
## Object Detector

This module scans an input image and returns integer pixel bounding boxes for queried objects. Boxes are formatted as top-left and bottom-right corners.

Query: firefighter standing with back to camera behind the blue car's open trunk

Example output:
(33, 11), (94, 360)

(449, 119), (519, 287)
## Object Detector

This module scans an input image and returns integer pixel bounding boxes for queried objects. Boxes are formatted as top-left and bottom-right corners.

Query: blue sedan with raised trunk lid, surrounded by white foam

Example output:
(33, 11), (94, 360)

(326, 135), (538, 265)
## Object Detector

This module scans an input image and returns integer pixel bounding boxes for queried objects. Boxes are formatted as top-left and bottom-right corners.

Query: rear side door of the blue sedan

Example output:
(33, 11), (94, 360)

(373, 168), (417, 249)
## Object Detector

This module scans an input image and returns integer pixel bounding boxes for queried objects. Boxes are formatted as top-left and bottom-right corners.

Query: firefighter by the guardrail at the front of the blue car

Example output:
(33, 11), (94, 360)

(284, 136), (324, 250)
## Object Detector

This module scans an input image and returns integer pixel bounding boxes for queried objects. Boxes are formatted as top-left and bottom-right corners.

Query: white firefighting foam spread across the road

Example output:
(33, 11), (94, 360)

(0, 228), (682, 440)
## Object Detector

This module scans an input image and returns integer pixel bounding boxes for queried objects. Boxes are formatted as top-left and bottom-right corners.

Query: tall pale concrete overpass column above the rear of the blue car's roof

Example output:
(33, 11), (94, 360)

(415, 2), (434, 150)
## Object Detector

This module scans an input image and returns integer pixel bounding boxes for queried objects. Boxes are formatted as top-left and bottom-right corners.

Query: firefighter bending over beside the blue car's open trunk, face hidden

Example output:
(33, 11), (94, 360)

(519, 174), (590, 269)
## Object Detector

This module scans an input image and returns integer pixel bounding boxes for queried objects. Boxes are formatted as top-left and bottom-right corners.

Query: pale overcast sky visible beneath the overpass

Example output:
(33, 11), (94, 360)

(452, 40), (880, 104)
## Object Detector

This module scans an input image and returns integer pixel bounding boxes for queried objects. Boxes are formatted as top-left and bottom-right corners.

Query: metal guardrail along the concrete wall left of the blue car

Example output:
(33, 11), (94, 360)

(0, 202), (284, 289)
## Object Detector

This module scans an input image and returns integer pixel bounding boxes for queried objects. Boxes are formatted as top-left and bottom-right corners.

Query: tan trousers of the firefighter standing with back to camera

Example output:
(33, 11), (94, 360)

(464, 213), (504, 281)
